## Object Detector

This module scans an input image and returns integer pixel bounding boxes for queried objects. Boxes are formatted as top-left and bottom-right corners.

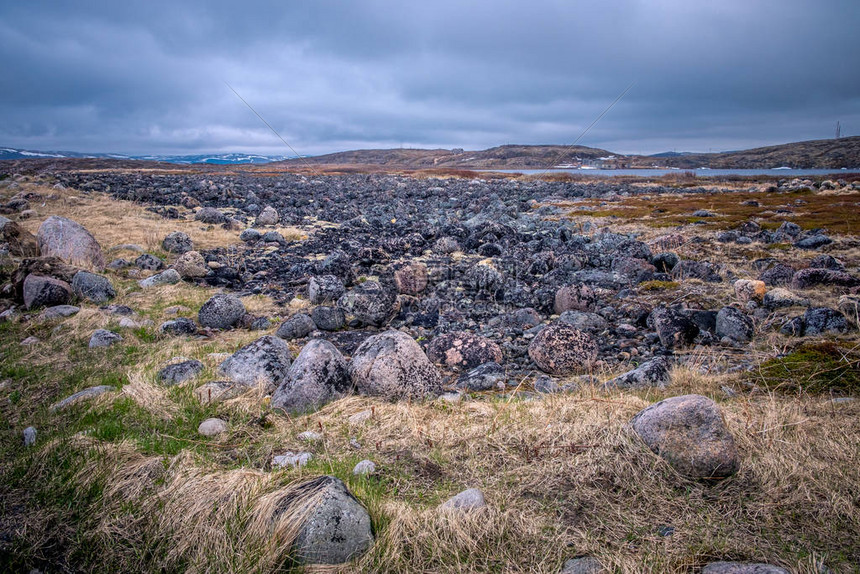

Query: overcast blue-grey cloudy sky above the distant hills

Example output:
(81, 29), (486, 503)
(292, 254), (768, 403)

(0, 0), (860, 155)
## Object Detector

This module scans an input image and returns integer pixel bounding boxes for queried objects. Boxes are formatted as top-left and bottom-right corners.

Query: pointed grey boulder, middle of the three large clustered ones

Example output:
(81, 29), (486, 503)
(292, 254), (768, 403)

(271, 339), (352, 414)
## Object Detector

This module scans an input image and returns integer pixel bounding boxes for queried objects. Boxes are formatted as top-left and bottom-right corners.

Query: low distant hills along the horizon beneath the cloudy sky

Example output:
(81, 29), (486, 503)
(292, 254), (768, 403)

(0, 136), (860, 170)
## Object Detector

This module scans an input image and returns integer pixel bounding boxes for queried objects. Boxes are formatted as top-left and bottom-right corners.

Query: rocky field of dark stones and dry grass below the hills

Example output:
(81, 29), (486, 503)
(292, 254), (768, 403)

(0, 162), (860, 574)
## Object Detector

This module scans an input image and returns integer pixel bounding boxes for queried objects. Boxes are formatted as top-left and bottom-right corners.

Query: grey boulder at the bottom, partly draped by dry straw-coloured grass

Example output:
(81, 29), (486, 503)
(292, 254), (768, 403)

(282, 476), (373, 564)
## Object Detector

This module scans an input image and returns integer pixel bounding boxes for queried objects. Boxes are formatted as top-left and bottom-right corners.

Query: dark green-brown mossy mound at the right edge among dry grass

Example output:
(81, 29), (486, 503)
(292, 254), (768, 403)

(751, 342), (860, 393)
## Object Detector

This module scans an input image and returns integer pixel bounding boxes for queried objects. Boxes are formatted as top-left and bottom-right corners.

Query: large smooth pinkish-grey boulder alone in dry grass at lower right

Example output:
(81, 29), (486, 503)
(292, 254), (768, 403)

(631, 395), (740, 479)
